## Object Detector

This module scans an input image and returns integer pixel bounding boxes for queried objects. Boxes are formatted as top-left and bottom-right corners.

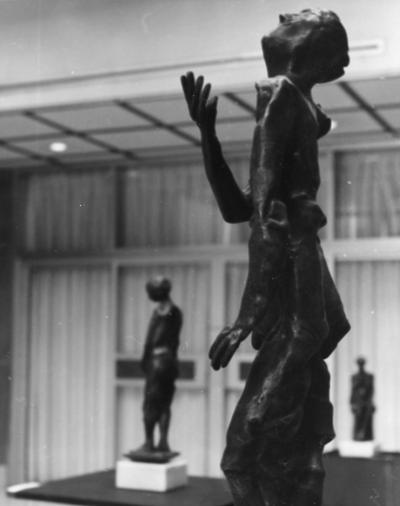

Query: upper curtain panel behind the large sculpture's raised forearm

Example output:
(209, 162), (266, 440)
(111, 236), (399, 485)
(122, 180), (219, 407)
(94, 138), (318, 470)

(119, 161), (252, 247)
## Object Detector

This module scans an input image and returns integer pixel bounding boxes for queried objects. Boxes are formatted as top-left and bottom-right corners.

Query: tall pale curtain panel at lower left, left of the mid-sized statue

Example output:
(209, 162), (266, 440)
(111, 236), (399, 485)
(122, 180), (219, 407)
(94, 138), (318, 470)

(22, 267), (113, 481)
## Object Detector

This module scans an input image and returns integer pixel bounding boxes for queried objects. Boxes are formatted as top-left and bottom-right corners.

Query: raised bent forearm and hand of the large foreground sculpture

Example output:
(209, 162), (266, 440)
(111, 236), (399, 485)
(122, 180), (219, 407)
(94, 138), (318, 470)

(181, 72), (253, 223)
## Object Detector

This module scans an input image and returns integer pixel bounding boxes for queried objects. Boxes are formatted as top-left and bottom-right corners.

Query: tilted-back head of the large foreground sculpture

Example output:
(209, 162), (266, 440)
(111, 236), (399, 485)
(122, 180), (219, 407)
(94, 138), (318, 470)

(261, 9), (350, 83)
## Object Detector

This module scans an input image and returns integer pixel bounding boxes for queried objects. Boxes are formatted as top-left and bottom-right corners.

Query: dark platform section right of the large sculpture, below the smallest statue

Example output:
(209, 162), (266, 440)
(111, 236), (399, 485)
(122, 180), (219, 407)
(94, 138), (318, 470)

(324, 453), (400, 506)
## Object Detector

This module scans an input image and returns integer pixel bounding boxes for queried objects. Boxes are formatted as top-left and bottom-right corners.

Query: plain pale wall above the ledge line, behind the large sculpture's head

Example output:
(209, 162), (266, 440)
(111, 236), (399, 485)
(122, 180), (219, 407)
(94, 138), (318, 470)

(0, 0), (400, 84)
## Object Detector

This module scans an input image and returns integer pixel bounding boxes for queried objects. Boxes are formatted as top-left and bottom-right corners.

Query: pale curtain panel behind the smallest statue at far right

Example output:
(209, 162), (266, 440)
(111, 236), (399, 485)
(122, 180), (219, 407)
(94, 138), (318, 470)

(335, 261), (400, 451)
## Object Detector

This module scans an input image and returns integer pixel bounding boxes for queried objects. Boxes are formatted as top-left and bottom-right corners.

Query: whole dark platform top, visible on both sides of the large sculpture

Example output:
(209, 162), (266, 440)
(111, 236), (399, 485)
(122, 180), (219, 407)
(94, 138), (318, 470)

(11, 454), (400, 506)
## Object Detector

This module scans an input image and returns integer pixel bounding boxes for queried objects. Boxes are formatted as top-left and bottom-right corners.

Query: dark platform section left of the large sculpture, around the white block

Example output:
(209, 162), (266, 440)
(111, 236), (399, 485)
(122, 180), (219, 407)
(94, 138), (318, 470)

(13, 469), (232, 506)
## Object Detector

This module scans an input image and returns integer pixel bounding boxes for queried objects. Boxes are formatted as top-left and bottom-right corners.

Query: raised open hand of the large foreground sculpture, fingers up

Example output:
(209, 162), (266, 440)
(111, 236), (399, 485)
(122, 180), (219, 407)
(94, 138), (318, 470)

(181, 72), (218, 131)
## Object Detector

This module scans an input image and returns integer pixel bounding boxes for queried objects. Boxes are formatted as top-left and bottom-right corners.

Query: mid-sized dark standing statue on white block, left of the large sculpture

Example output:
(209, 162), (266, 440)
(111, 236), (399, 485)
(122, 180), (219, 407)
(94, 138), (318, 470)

(126, 277), (183, 462)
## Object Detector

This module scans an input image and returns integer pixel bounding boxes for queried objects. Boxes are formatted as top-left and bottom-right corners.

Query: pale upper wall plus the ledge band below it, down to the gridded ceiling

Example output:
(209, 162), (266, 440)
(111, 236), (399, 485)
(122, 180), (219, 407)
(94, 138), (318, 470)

(0, 0), (400, 109)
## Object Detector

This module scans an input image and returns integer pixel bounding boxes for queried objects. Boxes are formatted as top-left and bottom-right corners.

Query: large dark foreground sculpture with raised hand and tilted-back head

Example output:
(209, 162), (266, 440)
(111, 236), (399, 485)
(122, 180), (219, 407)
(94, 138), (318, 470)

(182, 10), (350, 506)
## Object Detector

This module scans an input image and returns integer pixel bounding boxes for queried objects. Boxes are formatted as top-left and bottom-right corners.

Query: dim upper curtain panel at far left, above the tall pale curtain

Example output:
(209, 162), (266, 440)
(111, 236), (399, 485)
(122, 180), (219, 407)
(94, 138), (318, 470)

(19, 171), (114, 254)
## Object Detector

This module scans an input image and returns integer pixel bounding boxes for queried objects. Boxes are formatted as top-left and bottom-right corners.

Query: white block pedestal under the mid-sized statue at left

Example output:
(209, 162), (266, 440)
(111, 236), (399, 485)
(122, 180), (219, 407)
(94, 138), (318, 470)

(115, 457), (187, 492)
